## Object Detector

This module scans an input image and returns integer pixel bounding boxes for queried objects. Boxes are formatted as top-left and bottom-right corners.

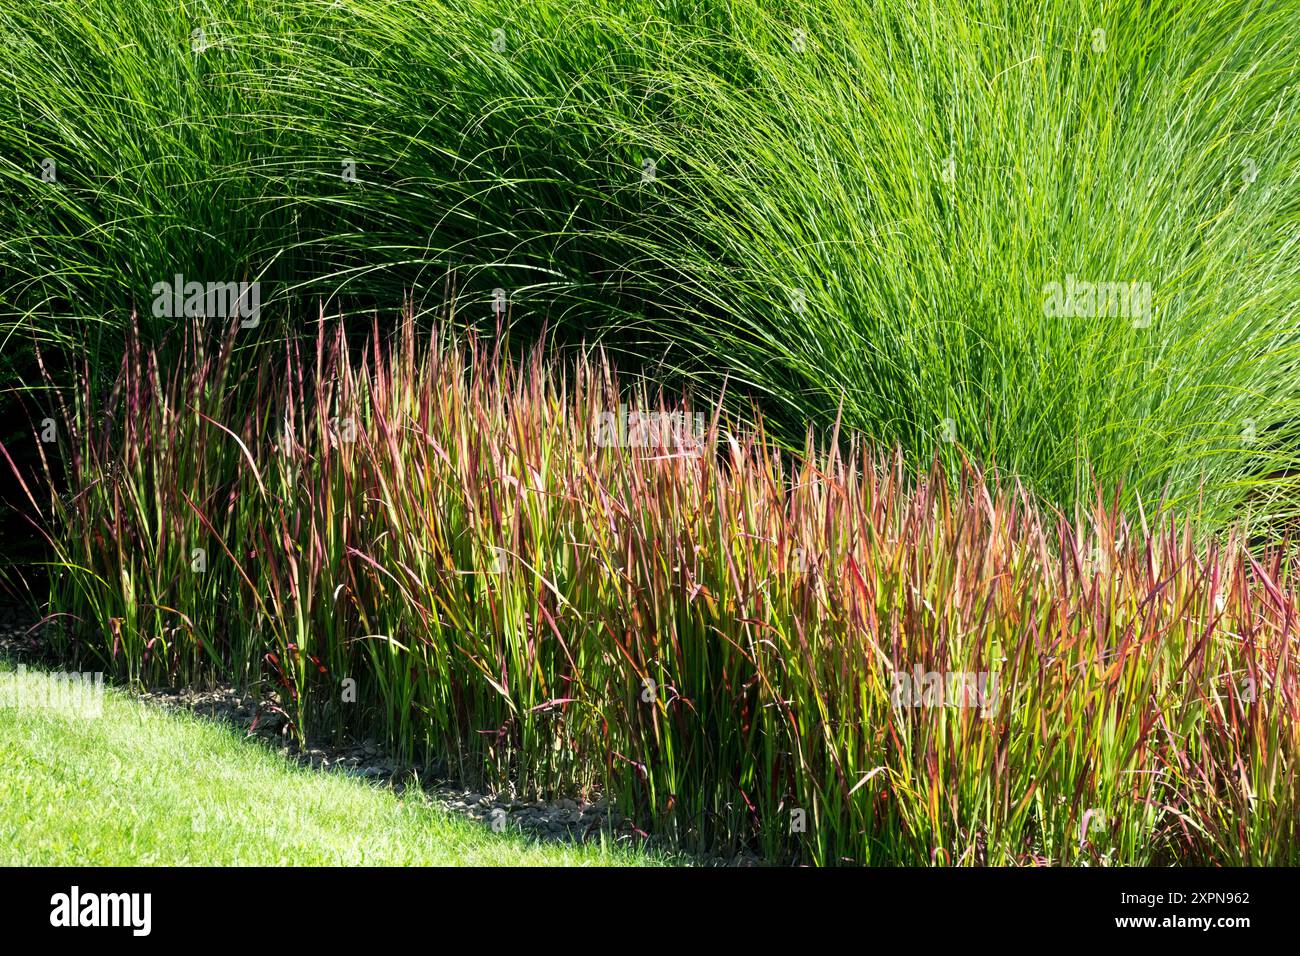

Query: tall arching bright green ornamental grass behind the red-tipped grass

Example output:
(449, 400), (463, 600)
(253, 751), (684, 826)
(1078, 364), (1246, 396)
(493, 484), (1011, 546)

(0, 0), (1300, 522)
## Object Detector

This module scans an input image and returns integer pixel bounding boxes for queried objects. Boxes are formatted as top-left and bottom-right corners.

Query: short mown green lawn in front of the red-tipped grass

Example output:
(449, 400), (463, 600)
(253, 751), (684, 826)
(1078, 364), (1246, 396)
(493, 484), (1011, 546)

(0, 665), (662, 866)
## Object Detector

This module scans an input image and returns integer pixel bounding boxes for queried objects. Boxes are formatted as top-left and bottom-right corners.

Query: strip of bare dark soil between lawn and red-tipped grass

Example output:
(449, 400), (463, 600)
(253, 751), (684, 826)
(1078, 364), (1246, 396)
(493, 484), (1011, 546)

(0, 606), (761, 866)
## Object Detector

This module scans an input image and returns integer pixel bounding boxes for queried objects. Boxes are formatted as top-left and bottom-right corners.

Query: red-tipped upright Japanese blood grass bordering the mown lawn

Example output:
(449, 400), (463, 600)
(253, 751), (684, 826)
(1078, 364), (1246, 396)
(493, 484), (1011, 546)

(10, 314), (1300, 865)
